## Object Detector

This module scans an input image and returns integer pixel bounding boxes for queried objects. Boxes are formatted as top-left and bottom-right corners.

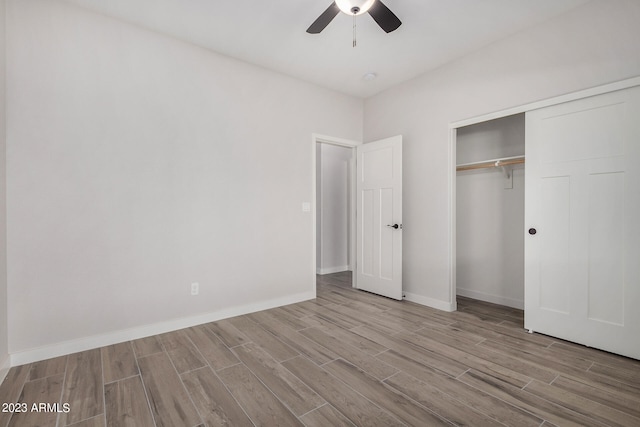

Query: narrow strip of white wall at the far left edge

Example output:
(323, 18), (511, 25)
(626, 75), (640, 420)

(0, 0), (9, 382)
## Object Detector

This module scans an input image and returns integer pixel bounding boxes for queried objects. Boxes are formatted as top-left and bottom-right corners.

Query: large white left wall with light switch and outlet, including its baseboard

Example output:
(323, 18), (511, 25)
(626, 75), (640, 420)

(7, 0), (363, 363)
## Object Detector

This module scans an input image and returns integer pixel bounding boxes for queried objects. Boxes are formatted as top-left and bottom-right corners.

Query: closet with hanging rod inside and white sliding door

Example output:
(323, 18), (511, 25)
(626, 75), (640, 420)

(452, 77), (640, 359)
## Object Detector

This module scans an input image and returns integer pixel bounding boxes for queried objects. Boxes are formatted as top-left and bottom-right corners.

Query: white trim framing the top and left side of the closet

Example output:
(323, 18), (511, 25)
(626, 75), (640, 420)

(448, 77), (640, 311)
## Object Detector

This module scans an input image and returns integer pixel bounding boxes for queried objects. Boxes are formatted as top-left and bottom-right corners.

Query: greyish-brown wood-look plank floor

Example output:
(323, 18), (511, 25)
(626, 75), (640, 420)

(0, 273), (640, 427)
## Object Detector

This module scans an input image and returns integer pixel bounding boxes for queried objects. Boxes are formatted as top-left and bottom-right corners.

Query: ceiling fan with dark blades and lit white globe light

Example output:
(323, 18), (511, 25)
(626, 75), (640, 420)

(307, 0), (402, 34)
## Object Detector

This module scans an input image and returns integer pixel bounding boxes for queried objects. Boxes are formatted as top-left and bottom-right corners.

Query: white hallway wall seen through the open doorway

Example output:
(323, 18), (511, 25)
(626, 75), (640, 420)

(316, 144), (352, 274)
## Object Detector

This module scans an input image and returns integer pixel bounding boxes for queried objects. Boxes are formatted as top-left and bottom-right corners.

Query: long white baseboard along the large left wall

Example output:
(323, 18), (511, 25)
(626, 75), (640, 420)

(10, 291), (316, 366)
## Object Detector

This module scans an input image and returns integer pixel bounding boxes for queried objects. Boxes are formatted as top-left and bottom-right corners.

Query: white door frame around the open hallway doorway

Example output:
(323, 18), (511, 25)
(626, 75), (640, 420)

(311, 133), (362, 293)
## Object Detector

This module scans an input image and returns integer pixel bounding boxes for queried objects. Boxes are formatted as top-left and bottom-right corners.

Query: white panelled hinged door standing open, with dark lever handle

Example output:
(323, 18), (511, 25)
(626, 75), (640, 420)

(356, 136), (402, 300)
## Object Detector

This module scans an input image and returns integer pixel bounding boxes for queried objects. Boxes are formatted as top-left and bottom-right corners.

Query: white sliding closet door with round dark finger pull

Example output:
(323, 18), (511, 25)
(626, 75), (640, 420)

(525, 87), (640, 359)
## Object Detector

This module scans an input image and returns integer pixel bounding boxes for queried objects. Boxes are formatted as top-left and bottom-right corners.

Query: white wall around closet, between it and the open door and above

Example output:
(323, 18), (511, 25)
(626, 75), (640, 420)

(364, 0), (640, 309)
